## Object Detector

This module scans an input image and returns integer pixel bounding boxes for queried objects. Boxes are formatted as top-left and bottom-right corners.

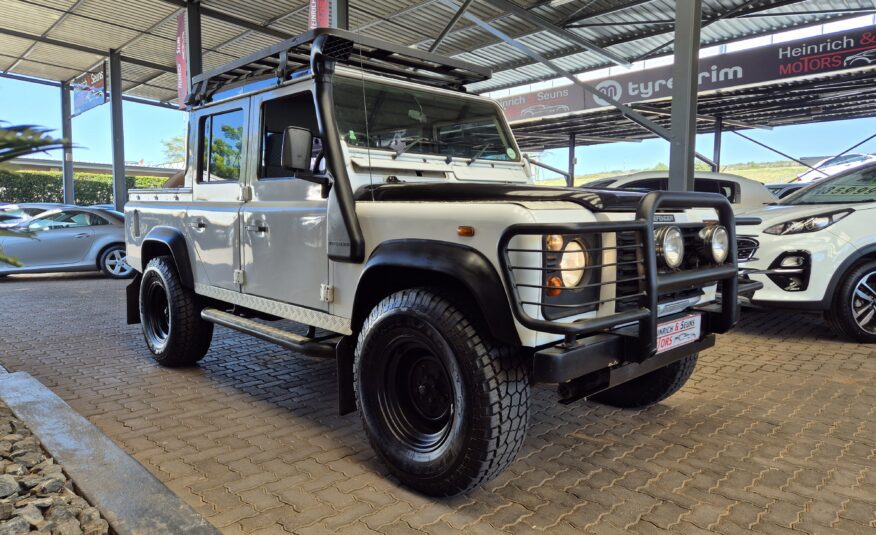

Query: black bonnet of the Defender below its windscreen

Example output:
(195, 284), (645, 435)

(356, 183), (644, 212)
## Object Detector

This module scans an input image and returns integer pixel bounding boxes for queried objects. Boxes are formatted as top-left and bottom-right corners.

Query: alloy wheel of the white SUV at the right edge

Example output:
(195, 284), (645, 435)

(825, 262), (876, 344)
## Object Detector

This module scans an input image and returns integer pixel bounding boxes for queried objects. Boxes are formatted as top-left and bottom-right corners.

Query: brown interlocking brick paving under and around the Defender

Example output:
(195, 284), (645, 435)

(0, 275), (876, 534)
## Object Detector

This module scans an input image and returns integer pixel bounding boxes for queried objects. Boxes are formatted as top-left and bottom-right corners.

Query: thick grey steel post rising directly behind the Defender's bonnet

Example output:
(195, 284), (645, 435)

(669, 0), (703, 191)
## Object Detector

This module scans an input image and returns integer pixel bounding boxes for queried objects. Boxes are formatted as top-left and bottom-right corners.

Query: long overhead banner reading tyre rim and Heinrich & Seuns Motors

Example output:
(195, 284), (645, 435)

(498, 26), (876, 121)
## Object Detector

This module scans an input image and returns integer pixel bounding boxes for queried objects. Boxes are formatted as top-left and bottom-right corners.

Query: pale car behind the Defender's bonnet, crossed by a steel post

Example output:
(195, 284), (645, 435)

(583, 171), (776, 213)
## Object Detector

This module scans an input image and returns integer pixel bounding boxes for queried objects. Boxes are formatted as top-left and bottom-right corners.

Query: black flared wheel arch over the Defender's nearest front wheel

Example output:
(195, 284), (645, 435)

(352, 239), (520, 346)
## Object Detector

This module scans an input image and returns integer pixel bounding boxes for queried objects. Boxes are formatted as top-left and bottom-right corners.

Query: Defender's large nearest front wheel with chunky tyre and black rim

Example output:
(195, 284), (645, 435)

(354, 289), (529, 496)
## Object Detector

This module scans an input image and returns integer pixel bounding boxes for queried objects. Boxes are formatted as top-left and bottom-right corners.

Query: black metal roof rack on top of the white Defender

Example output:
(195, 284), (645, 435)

(187, 28), (491, 105)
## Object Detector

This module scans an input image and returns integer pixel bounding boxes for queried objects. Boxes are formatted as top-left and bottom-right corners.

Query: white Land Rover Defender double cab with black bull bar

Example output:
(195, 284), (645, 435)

(125, 30), (756, 495)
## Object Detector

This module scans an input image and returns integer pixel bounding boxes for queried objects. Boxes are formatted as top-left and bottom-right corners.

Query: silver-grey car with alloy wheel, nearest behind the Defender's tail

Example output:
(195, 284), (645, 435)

(0, 207), (133, 279)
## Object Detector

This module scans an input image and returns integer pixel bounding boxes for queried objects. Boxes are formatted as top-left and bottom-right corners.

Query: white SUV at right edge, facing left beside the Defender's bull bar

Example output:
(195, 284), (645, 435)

(737, 161), (876, 343)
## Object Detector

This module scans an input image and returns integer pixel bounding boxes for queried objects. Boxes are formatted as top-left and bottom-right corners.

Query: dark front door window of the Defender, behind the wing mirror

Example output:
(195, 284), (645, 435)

(259, 91), (322, 179)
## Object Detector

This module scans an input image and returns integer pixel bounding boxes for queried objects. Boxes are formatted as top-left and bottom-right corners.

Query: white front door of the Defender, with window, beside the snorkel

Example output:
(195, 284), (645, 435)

(241, 84), (328, 311)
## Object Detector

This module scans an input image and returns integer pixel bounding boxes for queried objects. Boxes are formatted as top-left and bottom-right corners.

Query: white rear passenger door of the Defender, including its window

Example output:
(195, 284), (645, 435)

(185, 99), (249, 291)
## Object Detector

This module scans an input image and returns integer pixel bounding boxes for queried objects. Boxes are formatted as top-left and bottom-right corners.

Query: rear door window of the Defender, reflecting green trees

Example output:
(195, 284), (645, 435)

(200, 110), (244, 182)
